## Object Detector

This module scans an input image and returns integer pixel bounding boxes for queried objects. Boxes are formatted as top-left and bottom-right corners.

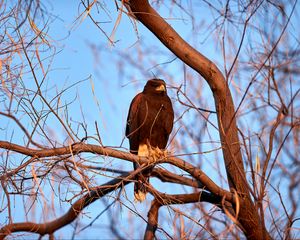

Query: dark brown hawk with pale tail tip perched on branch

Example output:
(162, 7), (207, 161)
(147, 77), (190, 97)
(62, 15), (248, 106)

(125, 78), (174, 202)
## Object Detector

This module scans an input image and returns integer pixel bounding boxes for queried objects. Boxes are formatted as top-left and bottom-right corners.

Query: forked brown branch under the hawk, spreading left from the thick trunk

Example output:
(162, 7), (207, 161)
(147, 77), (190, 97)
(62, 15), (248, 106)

(0, 141), (236, 239)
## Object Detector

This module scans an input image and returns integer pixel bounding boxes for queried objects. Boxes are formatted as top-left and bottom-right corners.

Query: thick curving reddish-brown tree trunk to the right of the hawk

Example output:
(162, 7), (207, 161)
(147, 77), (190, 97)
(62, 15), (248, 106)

(127, 0), (271, 239)
